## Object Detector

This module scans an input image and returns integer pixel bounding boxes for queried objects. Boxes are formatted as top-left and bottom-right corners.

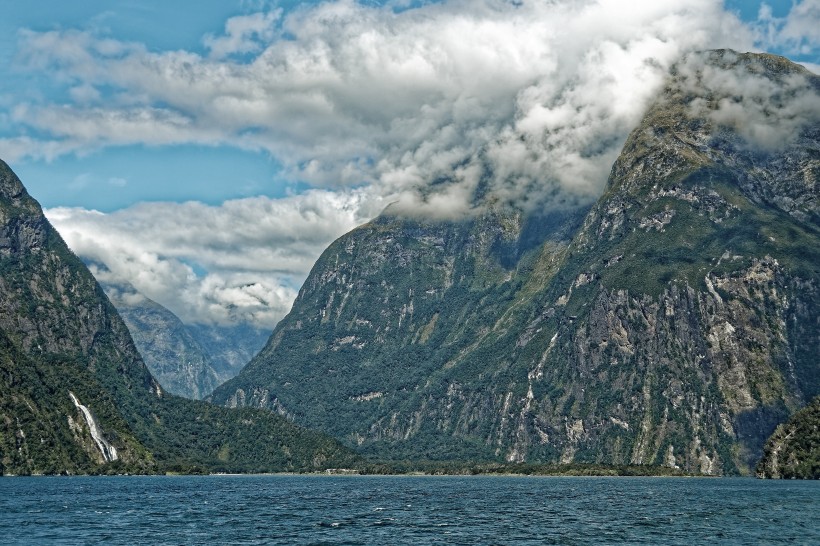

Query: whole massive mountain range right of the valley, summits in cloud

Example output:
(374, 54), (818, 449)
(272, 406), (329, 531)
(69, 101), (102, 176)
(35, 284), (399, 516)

(212, 51), (820, 474)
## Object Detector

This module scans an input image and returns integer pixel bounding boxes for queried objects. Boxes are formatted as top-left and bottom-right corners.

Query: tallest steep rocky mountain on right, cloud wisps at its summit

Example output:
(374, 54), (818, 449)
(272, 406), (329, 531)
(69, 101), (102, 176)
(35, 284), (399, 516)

(468, 51), (820, 473)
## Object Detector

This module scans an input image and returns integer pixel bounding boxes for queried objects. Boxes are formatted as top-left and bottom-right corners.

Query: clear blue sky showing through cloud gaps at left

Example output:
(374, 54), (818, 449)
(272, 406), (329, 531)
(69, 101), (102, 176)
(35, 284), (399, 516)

(0, 0), (298, 211)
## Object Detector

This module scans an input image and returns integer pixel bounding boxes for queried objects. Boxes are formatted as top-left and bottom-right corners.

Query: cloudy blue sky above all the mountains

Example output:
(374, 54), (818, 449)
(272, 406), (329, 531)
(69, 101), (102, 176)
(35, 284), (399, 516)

(0, 0), (820, 328)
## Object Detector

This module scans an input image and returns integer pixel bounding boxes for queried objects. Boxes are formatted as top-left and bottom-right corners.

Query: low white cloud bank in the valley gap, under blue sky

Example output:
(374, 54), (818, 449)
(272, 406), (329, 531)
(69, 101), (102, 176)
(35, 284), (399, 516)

(46, 190), (381, 328)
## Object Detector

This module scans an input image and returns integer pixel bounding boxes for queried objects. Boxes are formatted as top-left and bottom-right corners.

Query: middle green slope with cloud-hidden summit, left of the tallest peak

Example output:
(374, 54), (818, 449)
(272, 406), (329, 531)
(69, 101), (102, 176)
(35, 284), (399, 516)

(215, 205), (582, 458)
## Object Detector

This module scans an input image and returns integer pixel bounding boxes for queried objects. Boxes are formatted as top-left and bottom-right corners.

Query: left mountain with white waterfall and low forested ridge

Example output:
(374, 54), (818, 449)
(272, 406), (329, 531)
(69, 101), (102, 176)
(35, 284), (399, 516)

(0, 162), (358, 475)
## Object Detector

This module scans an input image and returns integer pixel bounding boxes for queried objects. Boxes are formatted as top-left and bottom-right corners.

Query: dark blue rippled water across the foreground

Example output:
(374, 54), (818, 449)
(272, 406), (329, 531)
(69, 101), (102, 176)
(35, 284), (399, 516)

(0, 476), (820, 546)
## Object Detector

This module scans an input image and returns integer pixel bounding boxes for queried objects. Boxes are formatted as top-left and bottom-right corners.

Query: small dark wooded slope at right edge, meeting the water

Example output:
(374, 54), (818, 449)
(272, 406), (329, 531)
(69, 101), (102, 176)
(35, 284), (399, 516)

(756, 396), (820, 480)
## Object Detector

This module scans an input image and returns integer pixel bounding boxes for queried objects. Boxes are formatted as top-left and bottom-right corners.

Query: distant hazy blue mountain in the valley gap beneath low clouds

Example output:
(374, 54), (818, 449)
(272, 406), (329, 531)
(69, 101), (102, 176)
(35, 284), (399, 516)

(103, 283), (270, 399)
